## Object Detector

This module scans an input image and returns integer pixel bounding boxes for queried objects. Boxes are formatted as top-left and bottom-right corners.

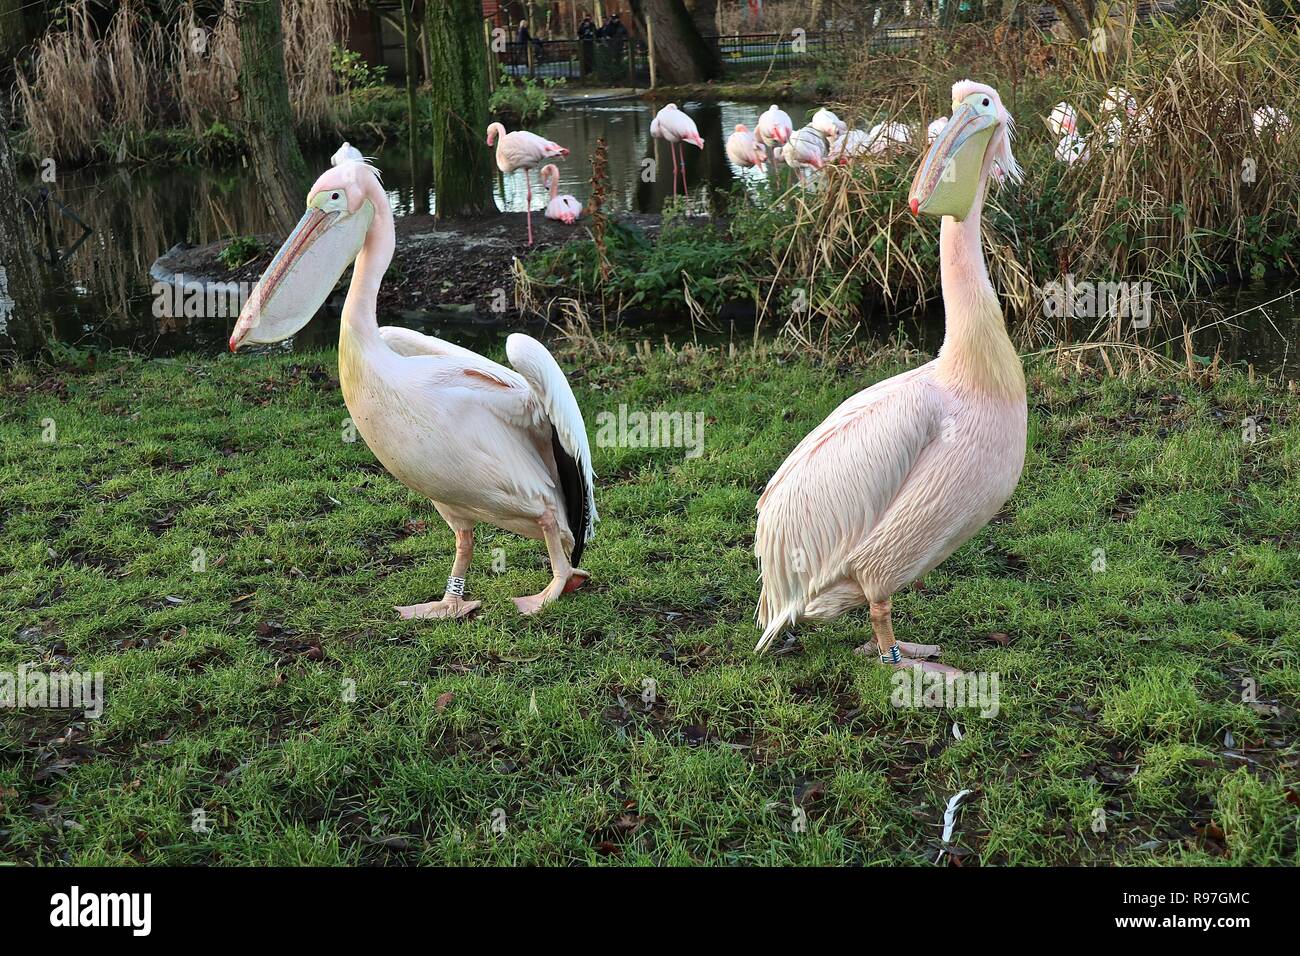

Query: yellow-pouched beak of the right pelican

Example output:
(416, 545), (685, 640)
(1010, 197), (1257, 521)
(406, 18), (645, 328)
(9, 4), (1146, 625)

(907, 103), (998, 221)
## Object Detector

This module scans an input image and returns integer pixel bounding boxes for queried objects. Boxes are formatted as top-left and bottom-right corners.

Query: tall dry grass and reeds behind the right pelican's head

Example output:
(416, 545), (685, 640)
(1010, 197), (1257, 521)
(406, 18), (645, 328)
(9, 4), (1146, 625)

(764, 3), (1300, 345)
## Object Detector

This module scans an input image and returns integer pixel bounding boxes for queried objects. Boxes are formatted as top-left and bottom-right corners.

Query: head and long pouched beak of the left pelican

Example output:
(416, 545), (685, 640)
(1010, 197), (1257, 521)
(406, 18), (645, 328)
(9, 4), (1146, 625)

(230, 143), (387, 351)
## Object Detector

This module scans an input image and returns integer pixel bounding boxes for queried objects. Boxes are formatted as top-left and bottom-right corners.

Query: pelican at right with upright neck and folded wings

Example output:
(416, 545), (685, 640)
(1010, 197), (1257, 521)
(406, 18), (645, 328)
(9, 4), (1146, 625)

(754, 79), (1027, 674)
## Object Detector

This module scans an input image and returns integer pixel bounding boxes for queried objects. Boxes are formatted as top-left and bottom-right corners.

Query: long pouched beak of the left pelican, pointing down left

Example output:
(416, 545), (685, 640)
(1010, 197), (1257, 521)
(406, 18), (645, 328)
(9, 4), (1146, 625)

(230, 194), (374, 351)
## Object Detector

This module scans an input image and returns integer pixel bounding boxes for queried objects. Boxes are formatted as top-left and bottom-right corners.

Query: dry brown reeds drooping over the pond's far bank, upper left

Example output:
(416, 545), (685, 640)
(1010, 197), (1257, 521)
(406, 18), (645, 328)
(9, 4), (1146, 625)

(13, 0), (352, 161)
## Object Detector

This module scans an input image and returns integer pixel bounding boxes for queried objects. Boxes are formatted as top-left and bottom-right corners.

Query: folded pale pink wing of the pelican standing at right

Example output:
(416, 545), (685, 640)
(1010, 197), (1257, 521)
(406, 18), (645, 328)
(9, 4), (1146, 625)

(754, 363), (943, 653)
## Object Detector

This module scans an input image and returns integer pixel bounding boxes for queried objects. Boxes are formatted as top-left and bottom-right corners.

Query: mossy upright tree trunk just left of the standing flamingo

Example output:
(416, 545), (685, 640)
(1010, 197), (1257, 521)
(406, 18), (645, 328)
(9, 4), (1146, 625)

(424, 0), (491, 219)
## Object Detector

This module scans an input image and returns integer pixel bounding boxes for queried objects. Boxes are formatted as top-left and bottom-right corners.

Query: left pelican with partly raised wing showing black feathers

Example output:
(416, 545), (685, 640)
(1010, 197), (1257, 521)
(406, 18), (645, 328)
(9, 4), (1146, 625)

(230, 143), (597, 618)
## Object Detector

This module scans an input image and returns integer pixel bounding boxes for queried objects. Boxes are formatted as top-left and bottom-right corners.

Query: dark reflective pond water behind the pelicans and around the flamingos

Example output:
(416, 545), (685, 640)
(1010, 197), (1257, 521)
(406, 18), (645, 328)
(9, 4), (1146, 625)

(15, 100), (1300, 375)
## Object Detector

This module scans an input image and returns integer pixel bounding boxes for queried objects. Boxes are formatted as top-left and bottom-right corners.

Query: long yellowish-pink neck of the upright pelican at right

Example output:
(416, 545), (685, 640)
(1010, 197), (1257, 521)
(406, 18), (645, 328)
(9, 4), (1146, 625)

(937, 189), (1024, 401)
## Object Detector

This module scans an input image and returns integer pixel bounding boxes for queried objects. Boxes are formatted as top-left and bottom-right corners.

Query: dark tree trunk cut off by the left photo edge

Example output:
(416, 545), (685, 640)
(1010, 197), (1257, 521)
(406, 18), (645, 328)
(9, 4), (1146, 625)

(0, 101), (46, 356)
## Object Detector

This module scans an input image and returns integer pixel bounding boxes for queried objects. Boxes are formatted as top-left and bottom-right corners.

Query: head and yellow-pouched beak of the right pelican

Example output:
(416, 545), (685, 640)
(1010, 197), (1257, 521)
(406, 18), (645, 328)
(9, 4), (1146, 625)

(907, 79), (1021, 221)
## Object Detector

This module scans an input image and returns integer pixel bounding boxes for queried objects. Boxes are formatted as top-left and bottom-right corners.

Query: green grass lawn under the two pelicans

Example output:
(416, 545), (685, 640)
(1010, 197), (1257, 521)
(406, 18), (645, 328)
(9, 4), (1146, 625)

(0, 351), (1300, 865)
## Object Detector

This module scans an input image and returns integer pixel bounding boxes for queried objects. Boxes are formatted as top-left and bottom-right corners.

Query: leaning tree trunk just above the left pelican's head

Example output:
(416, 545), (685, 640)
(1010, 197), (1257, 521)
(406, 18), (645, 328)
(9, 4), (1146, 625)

(239, 0), (311, 233)
